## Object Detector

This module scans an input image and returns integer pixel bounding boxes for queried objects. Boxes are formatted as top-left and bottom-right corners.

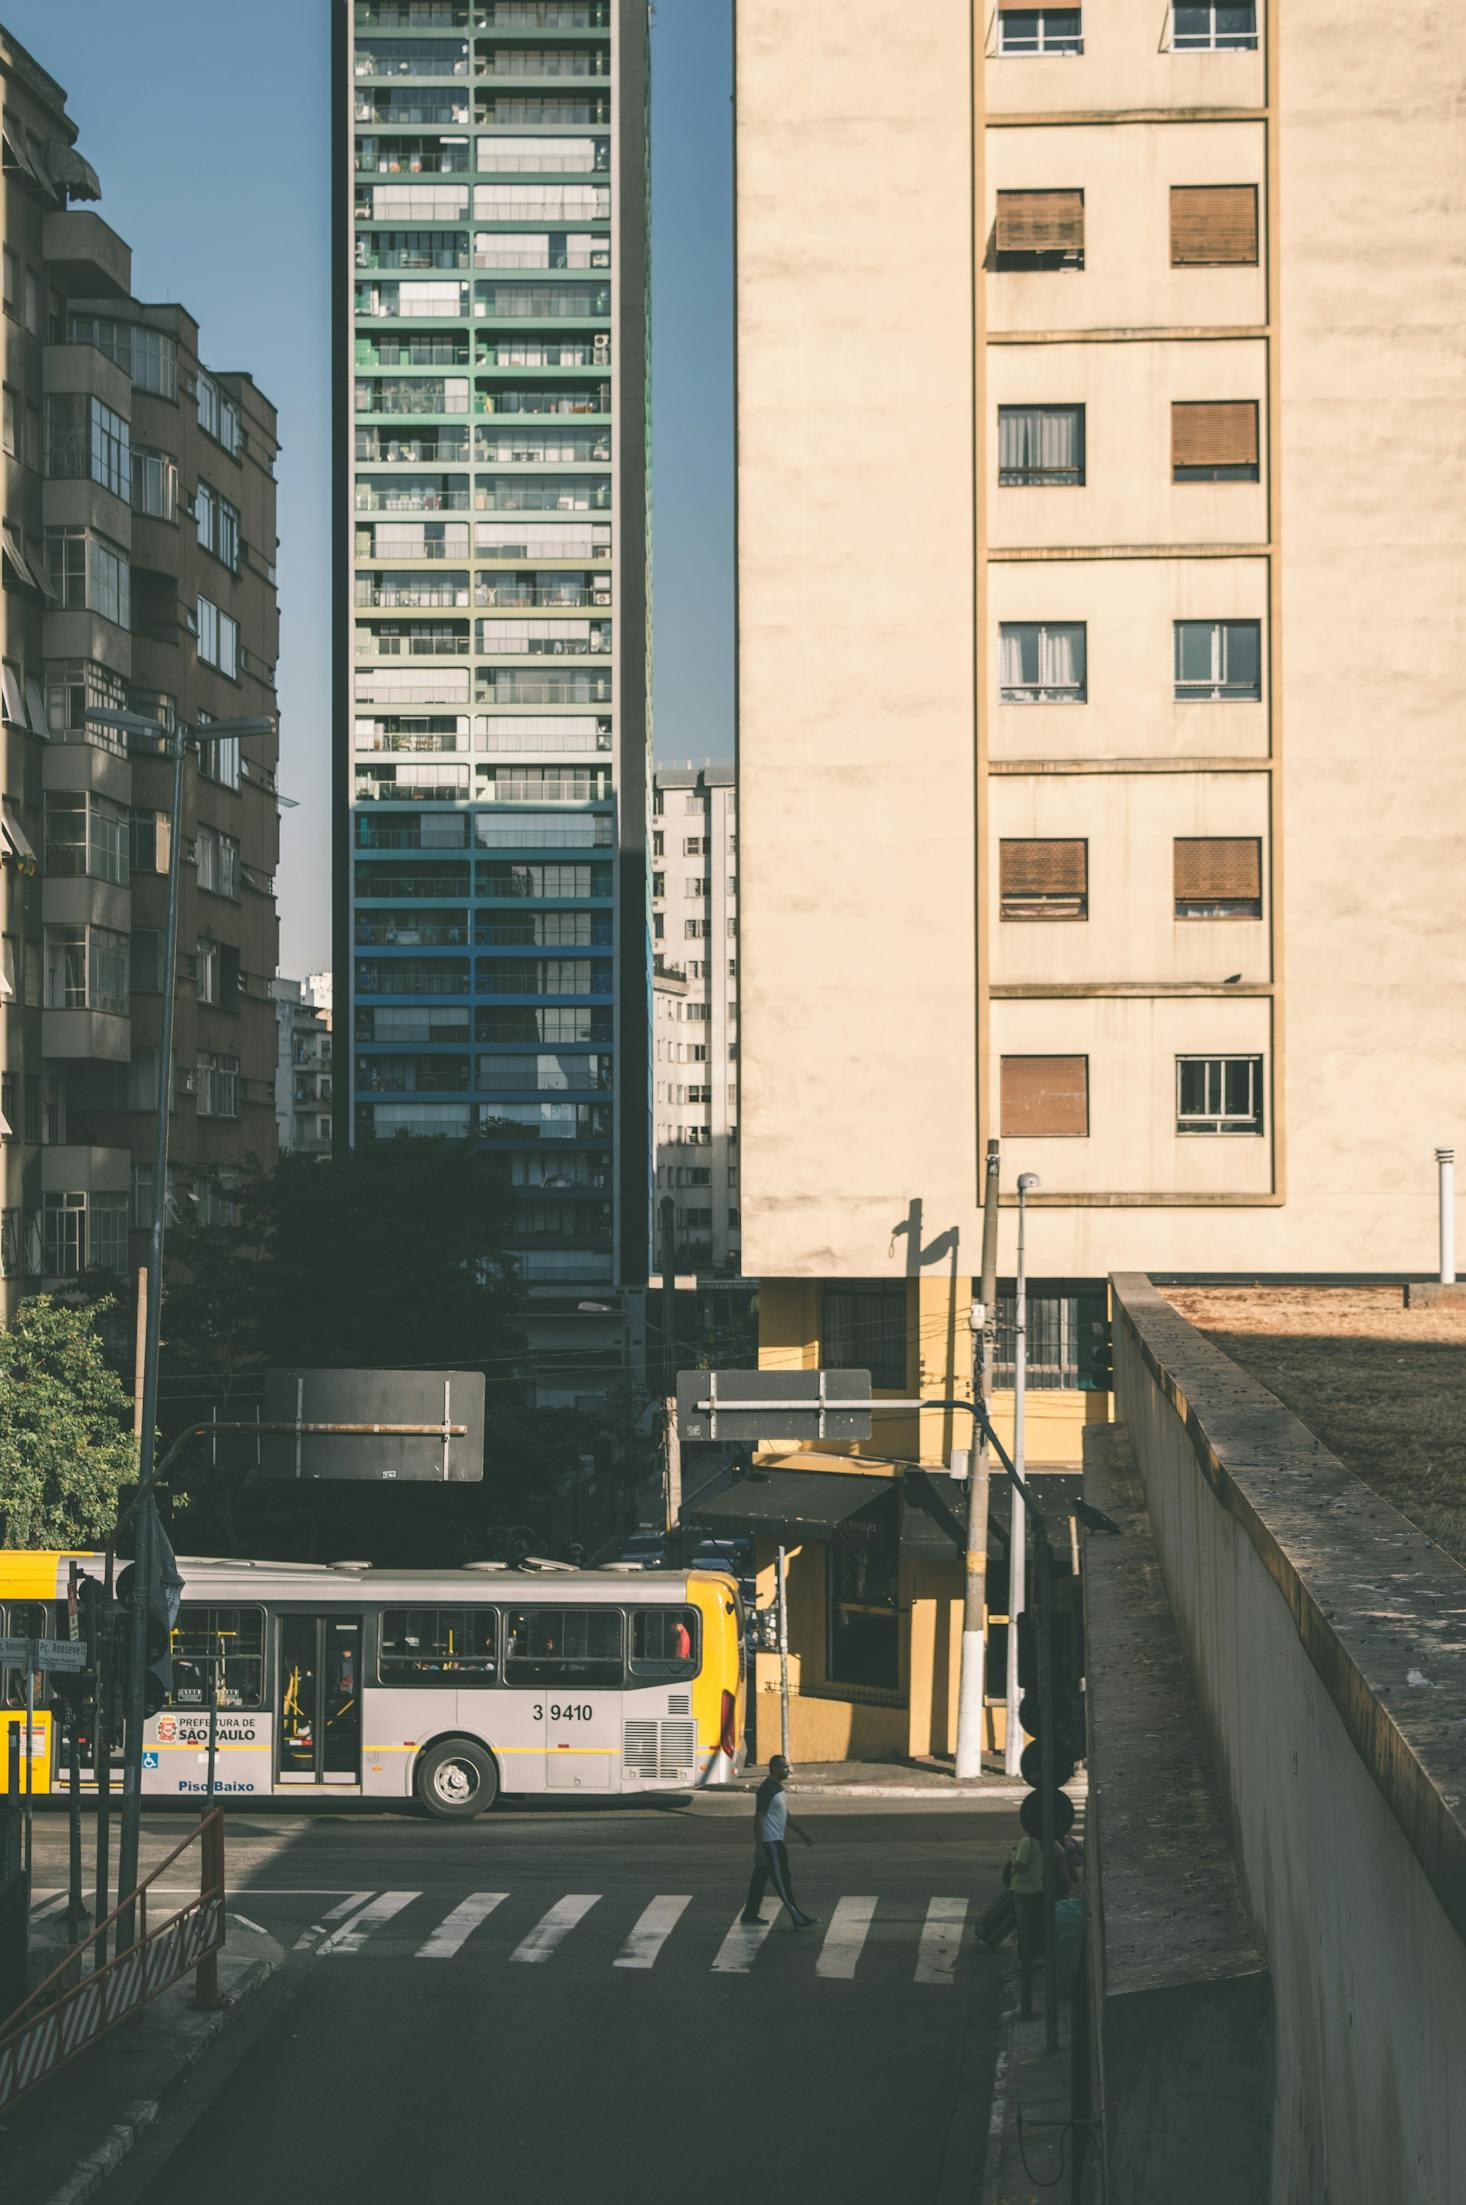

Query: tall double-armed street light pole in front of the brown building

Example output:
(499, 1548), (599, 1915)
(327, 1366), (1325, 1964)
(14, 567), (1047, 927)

(86, 710), (276, 1949)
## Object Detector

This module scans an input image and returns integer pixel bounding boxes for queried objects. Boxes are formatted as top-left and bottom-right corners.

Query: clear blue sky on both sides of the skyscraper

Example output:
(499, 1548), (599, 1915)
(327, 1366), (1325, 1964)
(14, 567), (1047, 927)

(0, 0), (732, 975)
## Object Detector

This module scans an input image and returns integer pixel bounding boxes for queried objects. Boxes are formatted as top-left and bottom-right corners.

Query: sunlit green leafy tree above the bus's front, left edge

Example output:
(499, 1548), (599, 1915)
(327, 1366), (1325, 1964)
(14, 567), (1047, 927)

(0, 1294), (137, 1548)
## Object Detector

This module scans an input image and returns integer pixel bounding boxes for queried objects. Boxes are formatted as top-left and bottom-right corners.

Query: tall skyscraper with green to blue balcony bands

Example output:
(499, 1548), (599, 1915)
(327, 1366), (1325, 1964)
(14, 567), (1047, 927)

(335, 0), (650, 1305)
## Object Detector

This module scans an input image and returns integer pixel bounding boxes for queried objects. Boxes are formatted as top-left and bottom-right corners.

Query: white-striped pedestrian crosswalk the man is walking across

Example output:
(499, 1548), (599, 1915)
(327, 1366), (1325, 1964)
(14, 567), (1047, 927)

(279, 1890), (970, 1987)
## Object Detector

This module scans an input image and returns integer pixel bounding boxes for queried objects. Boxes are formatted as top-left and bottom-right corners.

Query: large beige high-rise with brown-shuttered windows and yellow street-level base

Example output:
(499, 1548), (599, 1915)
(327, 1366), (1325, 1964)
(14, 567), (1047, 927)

(736, 0), (1466, 1755)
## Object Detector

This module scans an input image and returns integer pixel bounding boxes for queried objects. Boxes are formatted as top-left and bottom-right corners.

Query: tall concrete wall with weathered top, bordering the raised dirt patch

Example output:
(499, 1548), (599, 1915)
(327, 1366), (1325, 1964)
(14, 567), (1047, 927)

(1113, 1274), (1466, 2205)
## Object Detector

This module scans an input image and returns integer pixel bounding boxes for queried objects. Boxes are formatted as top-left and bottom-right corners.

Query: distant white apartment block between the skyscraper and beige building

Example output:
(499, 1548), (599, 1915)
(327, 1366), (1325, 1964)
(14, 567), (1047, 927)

(653, 765), (743, 1277)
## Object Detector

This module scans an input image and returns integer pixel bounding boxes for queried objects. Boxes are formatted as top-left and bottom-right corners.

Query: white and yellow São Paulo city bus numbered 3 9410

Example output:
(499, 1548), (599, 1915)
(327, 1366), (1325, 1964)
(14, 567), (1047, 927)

(0, 1552), (745, 1819)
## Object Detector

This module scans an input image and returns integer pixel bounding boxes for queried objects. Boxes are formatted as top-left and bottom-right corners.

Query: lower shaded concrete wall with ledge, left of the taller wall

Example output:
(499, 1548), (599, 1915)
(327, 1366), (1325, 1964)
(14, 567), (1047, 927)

(1085, 1427), (1274, 2205)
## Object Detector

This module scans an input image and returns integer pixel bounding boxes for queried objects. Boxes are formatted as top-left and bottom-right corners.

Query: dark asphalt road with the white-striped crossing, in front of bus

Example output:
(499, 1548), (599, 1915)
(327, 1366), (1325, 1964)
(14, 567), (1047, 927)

(37, 1795), (1016, 2205)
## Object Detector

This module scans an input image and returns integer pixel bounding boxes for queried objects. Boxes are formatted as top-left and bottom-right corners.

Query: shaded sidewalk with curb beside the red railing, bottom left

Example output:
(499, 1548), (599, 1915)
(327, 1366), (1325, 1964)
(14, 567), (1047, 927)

(0, 1914), (284, 2205)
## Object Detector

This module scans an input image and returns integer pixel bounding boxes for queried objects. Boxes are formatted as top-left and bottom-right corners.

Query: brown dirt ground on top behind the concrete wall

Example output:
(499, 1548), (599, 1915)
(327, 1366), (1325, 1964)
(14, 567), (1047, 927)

(1166, 1286), (1466, 1563)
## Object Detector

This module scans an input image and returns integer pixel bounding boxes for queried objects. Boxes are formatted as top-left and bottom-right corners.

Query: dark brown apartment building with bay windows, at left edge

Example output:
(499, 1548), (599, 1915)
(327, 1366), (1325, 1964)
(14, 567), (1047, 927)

(0, 33), (278, 1314)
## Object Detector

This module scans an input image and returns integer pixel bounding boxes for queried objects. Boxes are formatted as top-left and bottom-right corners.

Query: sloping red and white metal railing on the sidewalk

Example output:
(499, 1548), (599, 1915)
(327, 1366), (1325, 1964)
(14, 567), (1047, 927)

(0, 1808), (225, 2112)
